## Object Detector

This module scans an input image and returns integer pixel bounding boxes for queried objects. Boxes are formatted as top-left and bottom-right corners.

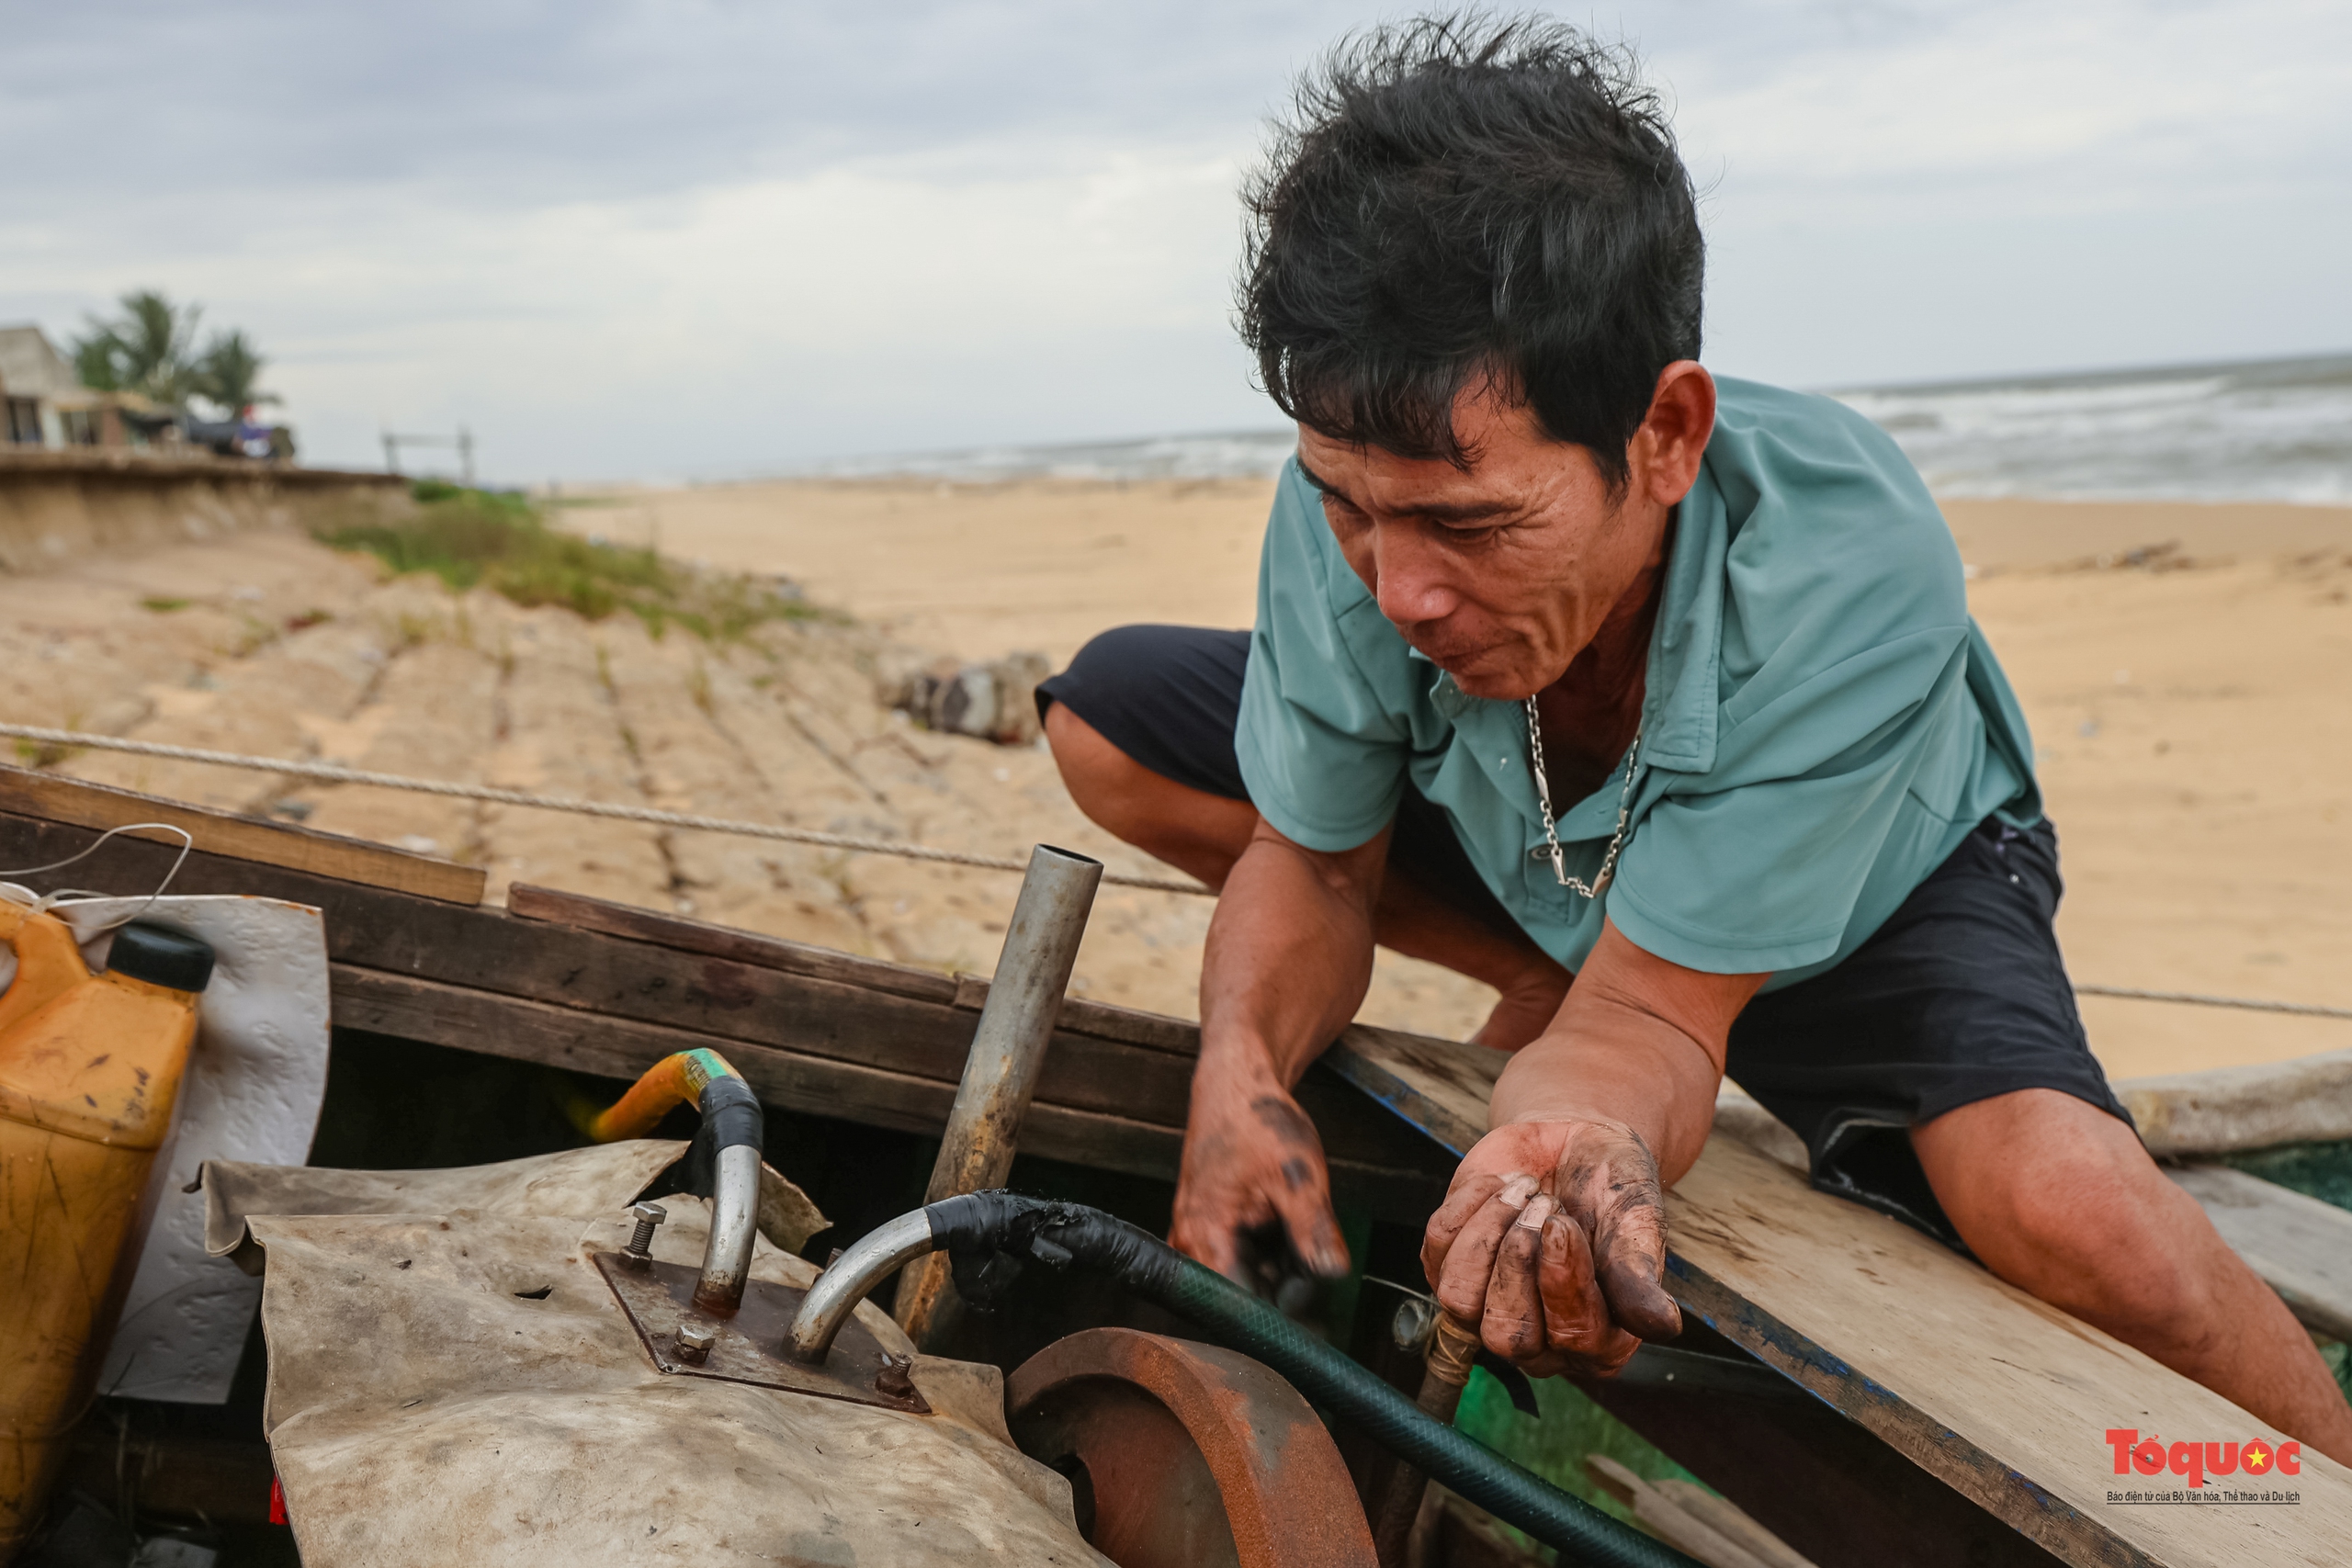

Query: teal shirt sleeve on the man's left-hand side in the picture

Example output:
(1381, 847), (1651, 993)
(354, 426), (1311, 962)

(1232, 463), (1411, 853)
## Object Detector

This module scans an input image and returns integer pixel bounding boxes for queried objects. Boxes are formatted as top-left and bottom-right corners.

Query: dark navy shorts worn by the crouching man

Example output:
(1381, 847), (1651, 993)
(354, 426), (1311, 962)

(1037, 626), (2131, 1246)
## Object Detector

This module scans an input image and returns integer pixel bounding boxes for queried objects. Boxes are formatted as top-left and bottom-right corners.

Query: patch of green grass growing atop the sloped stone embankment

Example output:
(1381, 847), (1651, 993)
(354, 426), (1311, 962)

(318, 479), (823, 642)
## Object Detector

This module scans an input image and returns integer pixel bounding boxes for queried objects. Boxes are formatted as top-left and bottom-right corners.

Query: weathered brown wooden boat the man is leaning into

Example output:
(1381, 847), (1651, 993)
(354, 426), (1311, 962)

(0, 769), (2352, 1568)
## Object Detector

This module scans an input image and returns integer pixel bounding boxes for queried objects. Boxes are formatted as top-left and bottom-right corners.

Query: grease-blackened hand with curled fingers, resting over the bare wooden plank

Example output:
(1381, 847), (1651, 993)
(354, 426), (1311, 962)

(1420, 1122), (1681, 1378)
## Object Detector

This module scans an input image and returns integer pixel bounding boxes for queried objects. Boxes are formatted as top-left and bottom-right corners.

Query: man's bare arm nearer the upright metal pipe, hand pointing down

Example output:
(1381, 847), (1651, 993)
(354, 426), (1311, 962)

(1169, 818), (1390, 1277)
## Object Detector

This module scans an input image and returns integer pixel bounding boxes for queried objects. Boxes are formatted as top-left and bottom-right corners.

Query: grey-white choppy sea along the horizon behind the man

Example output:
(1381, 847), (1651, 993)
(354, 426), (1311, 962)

(802, 355), (2352, 505)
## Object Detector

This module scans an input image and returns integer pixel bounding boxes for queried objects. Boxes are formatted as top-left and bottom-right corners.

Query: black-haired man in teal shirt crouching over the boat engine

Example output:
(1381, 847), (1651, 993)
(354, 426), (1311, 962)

(1040, 21), (2352, 1460)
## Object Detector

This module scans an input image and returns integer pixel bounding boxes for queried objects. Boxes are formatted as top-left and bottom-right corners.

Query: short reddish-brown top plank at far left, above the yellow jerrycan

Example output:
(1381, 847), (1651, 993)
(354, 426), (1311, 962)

(0, 766), (487, 905)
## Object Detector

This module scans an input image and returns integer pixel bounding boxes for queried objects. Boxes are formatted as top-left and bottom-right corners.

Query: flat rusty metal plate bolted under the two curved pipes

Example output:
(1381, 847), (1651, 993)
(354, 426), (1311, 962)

(591, 1251), (932, 1416)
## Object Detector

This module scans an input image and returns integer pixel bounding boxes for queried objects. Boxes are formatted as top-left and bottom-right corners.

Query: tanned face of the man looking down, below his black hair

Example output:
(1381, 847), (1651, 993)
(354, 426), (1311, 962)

(1298, 383), (1713, 698)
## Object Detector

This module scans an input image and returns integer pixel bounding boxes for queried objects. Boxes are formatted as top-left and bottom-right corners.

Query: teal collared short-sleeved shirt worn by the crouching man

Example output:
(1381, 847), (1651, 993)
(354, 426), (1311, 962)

(1235, 378), (2041, 989)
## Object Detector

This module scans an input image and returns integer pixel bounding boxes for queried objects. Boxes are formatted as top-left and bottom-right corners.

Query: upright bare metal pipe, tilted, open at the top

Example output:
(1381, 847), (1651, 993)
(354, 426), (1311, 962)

(896, 844), (1103, 1345)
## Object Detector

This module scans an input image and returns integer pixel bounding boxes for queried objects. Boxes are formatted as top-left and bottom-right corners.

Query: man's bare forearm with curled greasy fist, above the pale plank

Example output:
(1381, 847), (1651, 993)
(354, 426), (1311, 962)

(1420, 924), (1769, 1375)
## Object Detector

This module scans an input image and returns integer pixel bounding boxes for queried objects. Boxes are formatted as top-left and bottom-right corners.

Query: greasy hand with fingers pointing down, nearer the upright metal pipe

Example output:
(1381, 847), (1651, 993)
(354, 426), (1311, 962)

(1169, 1067), (1348, 1283)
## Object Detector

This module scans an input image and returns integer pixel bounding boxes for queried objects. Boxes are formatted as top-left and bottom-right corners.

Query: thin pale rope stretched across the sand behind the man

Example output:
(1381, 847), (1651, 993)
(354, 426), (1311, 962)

(0, 724), (2352, 1018)
